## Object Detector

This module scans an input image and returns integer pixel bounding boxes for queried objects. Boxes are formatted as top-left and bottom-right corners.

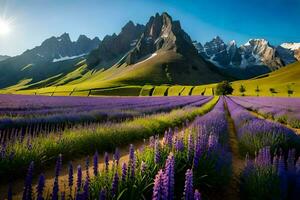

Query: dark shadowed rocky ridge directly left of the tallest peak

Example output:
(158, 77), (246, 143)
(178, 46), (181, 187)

(87, 21), (145, 67)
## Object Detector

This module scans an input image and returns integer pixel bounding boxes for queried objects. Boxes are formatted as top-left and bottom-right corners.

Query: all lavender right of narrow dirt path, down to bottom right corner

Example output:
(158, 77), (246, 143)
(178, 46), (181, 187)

(226, 98), (300, 199)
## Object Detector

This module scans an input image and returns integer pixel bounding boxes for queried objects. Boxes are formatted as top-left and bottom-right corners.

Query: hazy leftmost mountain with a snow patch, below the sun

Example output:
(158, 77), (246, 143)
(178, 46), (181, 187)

(0, 33), (100, 88)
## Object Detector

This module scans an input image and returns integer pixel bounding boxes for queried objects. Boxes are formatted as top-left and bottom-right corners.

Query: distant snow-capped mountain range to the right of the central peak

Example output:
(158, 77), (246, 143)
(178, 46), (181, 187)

(194, 36), (300, 78)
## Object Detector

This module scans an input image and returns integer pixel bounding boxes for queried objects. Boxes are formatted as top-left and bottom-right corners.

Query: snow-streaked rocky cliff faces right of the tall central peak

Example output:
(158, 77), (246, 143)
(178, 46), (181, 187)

(194, 37), (290, 70)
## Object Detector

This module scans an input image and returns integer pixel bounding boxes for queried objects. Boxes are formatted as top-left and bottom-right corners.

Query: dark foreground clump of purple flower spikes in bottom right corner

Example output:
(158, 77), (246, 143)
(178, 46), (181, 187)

(241, 146), (300, 199)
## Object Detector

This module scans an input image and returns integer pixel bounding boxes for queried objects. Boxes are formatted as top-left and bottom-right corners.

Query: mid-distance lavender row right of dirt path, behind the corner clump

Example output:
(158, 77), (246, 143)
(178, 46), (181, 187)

(226, 97), (300, 155)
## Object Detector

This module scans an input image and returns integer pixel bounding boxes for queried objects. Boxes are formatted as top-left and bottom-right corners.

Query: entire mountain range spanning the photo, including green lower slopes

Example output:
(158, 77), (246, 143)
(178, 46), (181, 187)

(0, 13), (300, 89)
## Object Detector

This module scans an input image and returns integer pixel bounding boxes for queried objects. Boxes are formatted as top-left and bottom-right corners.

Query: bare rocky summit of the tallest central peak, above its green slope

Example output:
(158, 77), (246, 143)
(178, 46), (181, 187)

(124, 13), (197, 65)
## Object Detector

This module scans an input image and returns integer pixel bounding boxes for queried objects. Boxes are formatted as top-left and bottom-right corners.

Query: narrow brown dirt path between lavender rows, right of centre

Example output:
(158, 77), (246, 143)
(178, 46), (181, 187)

(223, 102), (245, 200)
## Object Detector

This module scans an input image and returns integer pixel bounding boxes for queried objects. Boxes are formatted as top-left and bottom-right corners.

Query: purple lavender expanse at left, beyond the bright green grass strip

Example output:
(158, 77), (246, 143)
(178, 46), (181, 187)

(0, 95), (211, 145)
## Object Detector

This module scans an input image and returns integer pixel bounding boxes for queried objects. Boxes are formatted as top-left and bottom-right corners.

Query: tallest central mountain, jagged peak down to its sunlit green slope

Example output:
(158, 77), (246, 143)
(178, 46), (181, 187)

(86, 13), (224, 85)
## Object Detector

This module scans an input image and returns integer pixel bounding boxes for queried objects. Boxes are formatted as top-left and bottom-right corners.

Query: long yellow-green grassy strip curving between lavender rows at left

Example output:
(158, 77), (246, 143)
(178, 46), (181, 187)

(0, 97), (218, 180)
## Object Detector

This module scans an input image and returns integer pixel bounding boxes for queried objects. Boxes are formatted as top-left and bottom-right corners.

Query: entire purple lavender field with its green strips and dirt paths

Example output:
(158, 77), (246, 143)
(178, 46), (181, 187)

(0, 95), (300, 200)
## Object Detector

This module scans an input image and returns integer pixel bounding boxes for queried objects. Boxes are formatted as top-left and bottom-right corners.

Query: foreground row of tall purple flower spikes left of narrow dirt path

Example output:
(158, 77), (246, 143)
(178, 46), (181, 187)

(8, 97), (231, 200)
